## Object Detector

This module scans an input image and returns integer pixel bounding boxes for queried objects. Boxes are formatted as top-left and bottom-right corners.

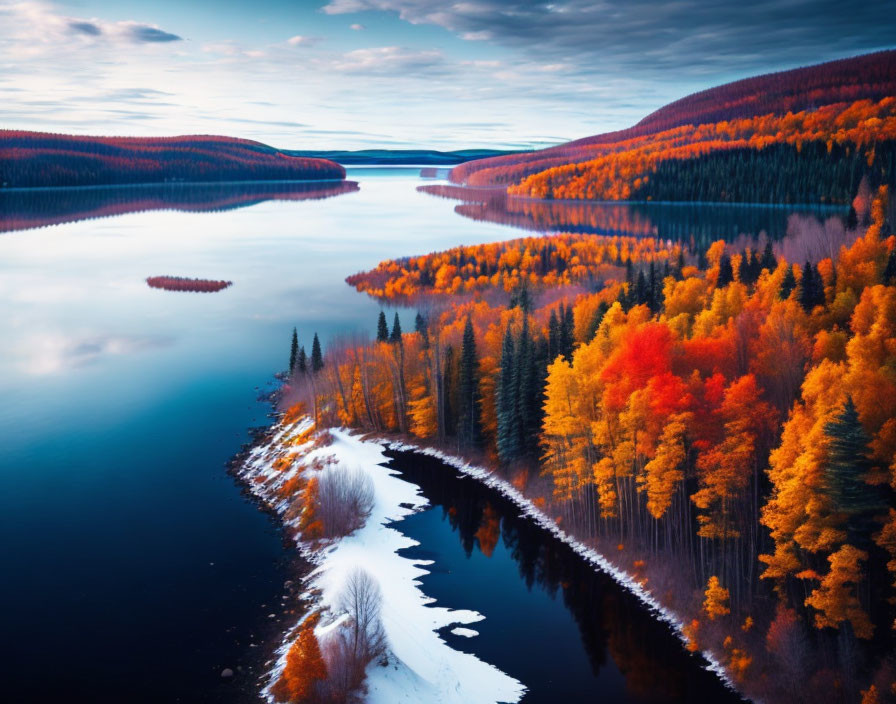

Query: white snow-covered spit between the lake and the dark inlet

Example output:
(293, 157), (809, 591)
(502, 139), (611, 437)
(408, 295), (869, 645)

(237, 419), (525, 704)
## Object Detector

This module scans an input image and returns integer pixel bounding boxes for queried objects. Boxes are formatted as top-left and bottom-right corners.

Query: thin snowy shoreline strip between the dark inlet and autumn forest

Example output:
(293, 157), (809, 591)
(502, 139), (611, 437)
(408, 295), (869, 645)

(382, 439), (759, 704)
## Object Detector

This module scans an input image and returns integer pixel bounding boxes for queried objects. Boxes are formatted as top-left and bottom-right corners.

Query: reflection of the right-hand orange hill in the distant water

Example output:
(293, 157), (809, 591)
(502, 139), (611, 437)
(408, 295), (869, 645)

(418, 185), (847, 249)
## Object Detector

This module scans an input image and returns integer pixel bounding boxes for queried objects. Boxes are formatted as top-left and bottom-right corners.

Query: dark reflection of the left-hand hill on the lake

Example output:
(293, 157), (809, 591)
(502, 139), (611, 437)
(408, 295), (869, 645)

(0, 181), (358, 232)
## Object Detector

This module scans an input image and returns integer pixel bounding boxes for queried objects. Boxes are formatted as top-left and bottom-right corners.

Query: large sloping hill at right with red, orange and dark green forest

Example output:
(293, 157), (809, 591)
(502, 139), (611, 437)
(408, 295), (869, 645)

(451, 50), (896, 203)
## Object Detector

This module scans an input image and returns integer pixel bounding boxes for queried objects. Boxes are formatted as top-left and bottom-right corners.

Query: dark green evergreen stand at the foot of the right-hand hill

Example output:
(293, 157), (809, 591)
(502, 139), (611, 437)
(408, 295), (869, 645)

(630, 140), (896, 204)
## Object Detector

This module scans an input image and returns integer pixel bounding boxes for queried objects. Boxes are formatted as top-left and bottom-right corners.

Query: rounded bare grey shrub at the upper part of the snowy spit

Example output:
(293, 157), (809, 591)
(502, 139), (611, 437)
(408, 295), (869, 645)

(317, 465), (373, 538)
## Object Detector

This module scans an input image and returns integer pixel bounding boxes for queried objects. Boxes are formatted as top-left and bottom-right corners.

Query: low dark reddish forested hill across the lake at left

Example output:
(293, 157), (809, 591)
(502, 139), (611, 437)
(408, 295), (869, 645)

(0, 130), (345, 188)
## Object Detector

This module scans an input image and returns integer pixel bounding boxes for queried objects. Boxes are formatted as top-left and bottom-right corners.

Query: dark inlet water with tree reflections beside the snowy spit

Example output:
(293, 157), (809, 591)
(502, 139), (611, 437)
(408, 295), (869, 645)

(387, 452), (739, 704)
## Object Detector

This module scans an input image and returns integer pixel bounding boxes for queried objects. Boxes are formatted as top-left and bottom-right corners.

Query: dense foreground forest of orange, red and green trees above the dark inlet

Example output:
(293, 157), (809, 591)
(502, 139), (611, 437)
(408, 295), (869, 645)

(292, 188), (896, 702)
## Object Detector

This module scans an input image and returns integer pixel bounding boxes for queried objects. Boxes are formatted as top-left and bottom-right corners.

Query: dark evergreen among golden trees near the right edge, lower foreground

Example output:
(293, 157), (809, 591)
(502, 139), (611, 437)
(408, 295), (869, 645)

(824, 397), (885, 548)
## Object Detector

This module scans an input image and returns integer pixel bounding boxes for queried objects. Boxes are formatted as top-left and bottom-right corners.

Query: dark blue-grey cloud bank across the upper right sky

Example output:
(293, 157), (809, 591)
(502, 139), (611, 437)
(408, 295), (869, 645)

(324, 0), (896, 79)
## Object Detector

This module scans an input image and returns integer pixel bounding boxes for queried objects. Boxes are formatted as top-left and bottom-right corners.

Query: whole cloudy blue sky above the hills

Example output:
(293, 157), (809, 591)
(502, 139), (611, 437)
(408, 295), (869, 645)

(0, 0), (896, 149)
